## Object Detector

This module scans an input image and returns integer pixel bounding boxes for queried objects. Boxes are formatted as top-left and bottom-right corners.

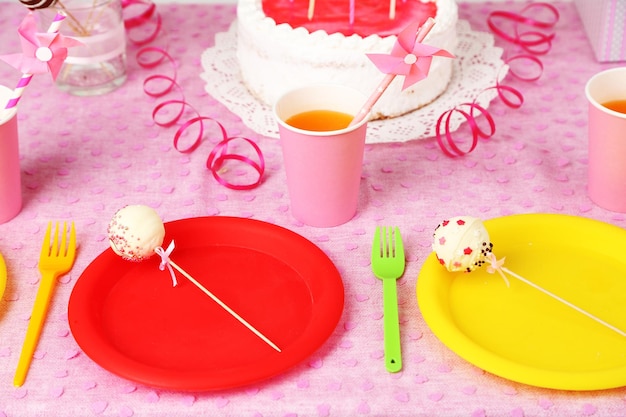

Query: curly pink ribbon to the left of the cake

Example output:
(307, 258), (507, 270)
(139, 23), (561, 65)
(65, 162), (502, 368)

(123, 0), (265, 190)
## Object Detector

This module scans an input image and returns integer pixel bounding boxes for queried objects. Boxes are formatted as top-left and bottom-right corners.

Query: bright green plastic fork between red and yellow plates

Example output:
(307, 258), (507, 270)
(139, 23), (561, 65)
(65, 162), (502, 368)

(372, 227), (405, 372)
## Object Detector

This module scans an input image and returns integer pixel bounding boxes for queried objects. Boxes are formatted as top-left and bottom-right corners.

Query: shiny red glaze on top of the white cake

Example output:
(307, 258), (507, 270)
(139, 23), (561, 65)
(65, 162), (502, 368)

(263, 0), (437, 38)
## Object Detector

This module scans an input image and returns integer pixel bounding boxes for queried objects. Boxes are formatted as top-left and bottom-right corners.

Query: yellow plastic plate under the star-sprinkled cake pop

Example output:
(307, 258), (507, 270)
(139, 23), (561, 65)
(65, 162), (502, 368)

(417, 214), (626, 391)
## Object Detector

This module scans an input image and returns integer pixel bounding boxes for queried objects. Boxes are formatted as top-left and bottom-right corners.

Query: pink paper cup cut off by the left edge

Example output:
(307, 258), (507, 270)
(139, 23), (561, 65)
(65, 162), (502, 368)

(0, 86), (22, 224)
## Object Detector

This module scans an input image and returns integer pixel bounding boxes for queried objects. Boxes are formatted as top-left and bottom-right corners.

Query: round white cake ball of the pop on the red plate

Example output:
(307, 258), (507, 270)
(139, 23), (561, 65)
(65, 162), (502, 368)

(107, 205), (165, 262)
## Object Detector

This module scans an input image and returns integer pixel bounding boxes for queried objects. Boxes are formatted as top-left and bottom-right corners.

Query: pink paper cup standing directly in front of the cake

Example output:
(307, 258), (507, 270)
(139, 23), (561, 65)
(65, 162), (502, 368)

(274, 85), (367, 227)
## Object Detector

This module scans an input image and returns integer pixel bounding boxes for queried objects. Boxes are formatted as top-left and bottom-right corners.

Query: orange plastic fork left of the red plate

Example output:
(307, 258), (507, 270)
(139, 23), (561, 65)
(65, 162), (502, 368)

(13, 222), (76, 387)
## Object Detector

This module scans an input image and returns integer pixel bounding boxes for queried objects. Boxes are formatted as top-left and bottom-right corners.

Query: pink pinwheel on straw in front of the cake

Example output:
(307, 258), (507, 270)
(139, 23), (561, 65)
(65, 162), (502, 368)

(367, 19), (454, 90)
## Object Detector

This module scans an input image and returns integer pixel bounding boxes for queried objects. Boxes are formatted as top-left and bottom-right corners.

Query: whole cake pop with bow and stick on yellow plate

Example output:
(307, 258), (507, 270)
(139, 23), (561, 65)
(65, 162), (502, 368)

(432, 216), (626, 336)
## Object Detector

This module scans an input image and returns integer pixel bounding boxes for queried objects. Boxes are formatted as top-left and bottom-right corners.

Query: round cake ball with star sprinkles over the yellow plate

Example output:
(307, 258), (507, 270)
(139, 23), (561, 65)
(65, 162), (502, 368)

(433, 216), (493, 272)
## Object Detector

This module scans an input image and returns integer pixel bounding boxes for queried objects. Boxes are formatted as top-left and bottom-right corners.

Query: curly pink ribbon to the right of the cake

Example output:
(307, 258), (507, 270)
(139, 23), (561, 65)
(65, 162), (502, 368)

(435, 3), (559, 157)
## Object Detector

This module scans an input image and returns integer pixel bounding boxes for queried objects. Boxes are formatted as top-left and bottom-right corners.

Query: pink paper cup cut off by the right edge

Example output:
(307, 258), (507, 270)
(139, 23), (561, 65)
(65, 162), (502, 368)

(585, 67), (626, 213)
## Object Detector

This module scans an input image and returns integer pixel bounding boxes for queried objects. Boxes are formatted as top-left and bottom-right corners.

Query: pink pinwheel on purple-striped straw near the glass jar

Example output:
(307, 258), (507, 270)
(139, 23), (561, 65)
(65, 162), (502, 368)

(0, 13), (82, 79)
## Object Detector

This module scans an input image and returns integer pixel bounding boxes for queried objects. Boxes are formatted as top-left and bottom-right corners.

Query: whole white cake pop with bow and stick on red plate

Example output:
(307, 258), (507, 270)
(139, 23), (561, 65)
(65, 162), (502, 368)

(108, 205), (281, 352)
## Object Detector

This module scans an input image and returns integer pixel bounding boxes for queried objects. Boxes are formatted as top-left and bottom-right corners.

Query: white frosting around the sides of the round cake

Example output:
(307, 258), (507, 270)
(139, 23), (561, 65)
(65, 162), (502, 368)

(237, 0), (457, 119)
